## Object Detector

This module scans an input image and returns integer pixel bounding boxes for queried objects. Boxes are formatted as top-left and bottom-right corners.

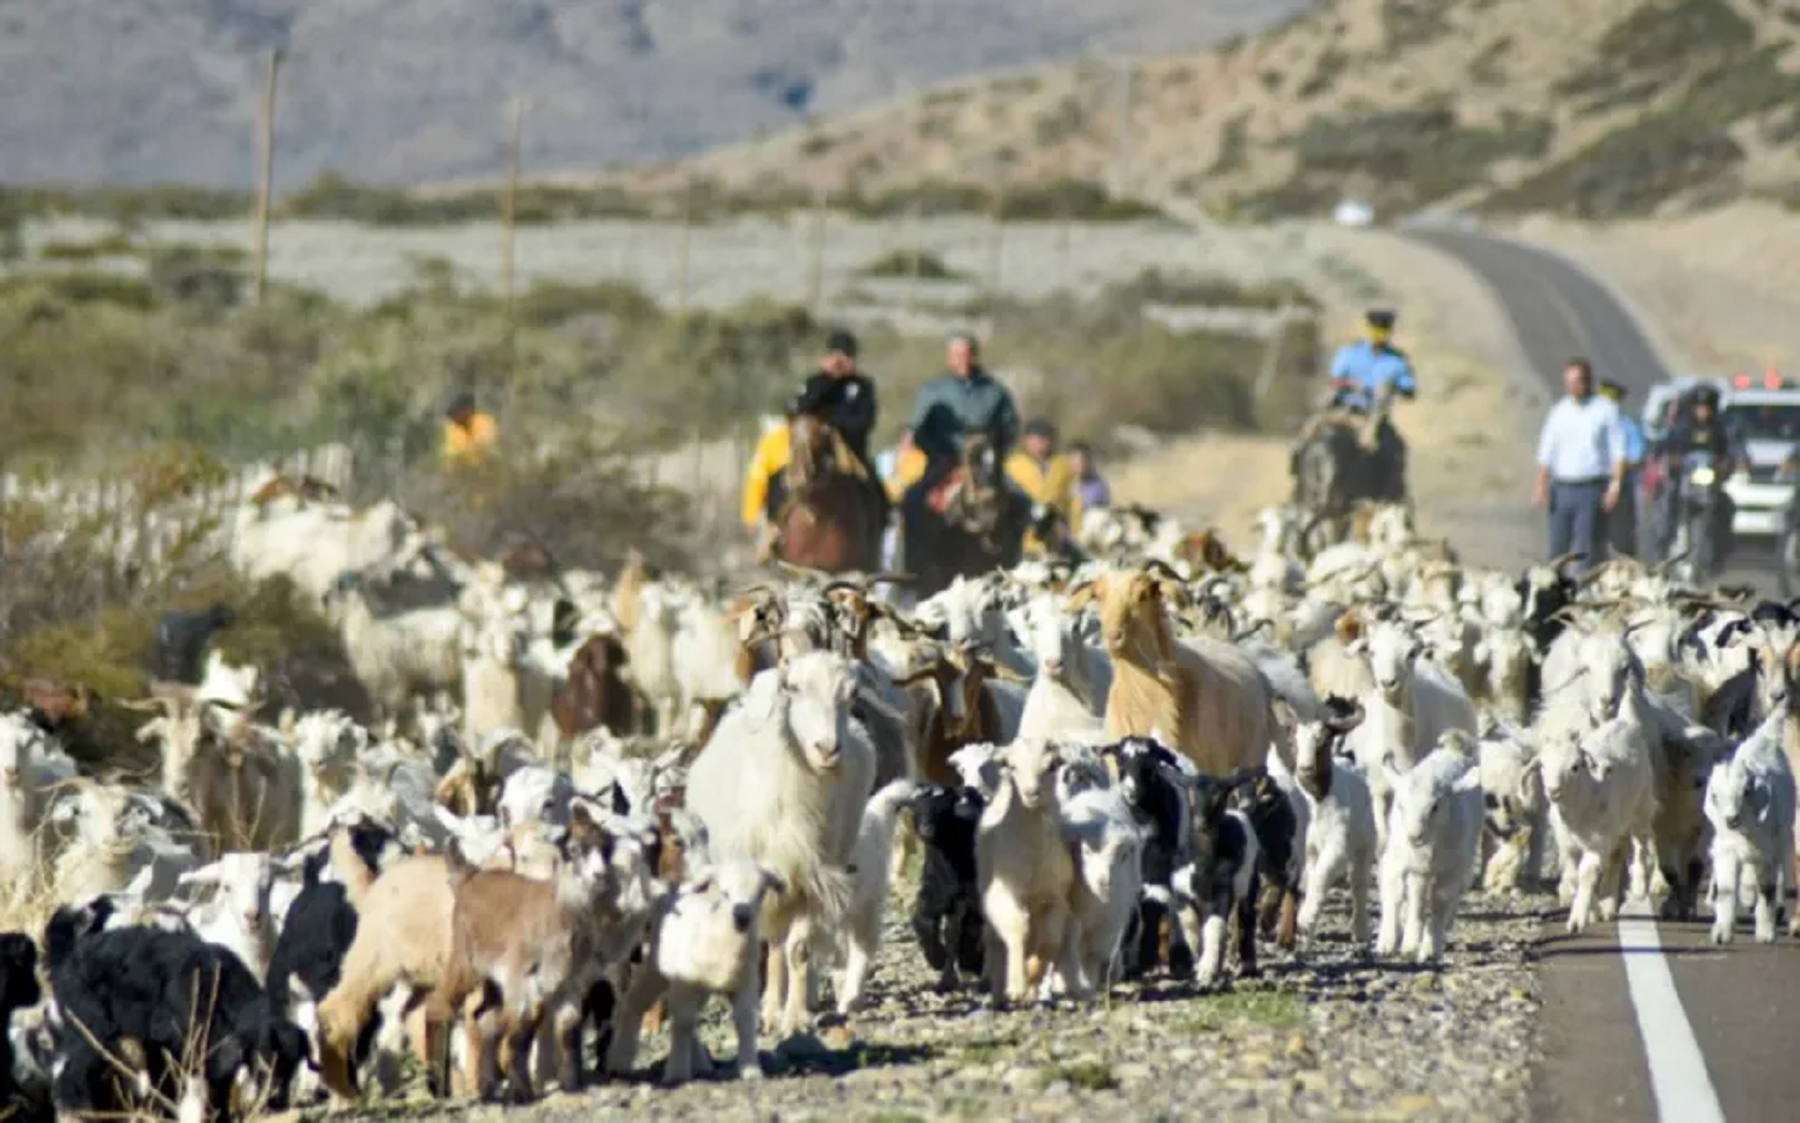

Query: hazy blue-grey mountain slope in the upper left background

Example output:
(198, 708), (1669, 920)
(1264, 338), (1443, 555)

(0, 0), (1310, 187)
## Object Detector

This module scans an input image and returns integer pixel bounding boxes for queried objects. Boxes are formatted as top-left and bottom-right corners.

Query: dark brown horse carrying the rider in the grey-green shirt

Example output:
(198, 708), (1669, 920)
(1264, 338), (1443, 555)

(902, 434), (1031, 597)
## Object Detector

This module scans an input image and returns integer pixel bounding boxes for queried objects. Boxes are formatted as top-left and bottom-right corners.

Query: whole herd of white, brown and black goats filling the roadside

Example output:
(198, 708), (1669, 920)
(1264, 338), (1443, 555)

(0, 479), (1800, 1119)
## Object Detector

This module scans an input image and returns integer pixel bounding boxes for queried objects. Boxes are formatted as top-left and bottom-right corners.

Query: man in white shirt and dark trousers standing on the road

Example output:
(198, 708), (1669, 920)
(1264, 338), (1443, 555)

(1532, 358), (1625, 565)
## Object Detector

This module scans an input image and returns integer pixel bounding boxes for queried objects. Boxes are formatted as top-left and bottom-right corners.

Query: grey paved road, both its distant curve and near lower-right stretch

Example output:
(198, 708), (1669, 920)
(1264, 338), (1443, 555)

(1413, 230), (1800, 1123)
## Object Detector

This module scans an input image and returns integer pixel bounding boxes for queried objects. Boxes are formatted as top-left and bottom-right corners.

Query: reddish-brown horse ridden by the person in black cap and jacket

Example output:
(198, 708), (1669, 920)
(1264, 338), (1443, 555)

(772, 414), (882, 574)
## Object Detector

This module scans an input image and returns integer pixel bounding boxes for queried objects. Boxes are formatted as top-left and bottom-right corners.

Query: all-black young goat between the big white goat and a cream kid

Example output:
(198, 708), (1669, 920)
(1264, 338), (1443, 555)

(905, 785), (986, 990)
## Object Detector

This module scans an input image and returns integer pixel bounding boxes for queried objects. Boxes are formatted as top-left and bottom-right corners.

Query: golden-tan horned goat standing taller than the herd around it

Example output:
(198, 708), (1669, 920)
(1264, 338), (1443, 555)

(1069, 569), (1280, 776)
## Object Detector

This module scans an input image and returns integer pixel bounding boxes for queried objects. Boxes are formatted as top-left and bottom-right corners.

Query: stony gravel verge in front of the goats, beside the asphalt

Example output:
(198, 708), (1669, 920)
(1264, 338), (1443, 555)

(320, 881), (1541, 1123)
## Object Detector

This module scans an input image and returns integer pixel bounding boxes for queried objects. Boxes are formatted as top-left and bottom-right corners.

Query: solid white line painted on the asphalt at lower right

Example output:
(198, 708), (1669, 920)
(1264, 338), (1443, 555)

(1618, 900), (1724, 1123)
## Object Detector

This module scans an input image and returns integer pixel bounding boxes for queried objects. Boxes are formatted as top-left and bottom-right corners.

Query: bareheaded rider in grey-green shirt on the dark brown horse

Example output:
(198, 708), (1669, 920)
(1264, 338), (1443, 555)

(900, 331), (1024, 515)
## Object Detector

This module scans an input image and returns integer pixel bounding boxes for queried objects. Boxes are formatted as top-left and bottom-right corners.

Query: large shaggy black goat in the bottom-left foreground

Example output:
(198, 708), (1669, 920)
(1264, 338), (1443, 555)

(45, 909), (308, 1119)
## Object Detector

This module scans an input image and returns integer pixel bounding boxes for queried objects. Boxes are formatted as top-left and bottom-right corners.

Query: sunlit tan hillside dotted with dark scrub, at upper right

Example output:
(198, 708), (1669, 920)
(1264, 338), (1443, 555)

(615, 0), (1800, 218)
